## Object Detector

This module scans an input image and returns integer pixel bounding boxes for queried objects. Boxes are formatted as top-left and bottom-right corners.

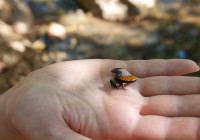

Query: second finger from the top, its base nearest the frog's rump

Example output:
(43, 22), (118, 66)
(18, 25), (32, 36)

(138, 76), (200, 97)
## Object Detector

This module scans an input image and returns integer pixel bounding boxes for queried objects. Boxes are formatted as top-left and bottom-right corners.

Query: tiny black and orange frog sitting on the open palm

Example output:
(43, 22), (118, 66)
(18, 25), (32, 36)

(110, 68), (137, 89)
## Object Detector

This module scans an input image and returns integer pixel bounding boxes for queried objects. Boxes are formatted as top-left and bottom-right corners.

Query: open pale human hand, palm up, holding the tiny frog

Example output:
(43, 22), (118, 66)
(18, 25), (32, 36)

(0, 60), (200, 140)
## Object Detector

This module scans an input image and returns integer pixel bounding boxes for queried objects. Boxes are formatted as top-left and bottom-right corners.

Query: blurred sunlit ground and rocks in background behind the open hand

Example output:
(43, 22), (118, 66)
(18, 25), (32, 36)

(0, 0), (200, 94)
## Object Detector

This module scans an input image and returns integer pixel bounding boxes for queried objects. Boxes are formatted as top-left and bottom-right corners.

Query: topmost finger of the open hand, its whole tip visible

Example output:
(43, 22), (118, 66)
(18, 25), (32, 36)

(127, 59), (199, 78)
